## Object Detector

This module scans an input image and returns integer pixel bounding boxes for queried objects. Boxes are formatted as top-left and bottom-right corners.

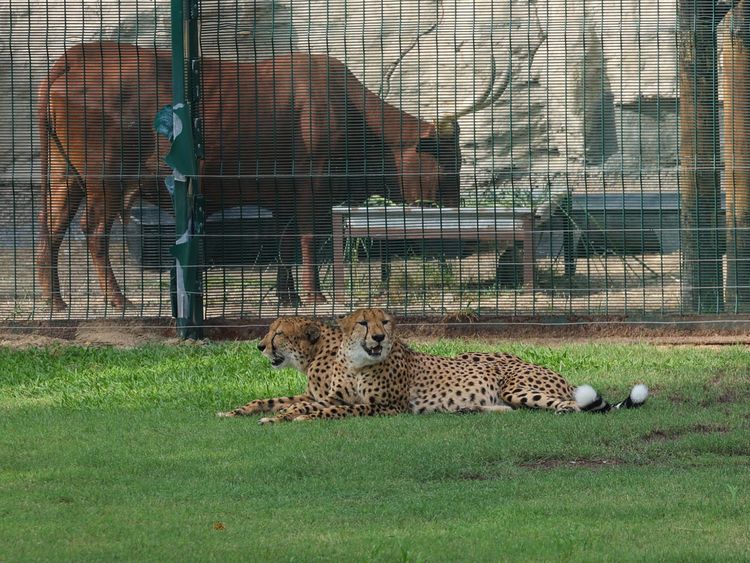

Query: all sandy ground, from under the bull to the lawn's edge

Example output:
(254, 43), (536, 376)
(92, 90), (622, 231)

(0, 225), (750, 347)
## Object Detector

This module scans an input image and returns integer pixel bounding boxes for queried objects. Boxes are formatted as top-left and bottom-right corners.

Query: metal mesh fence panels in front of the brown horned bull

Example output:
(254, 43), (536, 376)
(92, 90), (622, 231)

(0, 0), (750, 321)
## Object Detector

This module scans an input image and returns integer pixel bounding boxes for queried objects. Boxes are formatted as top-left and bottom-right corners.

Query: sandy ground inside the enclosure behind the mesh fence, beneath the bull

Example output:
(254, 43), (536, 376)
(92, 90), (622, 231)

(0, 240), (692, 322)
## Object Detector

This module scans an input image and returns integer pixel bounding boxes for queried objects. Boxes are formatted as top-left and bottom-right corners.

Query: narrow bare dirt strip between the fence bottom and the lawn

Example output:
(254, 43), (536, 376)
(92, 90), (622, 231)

(0, 310), (750, 348)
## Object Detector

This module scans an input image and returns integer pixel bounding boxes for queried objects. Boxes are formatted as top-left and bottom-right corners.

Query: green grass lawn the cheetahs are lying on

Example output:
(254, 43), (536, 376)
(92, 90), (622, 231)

(0, 341), (750, 562)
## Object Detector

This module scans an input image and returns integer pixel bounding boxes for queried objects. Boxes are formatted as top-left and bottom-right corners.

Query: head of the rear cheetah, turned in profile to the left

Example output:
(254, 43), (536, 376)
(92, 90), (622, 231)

(258, 317), (321, 372)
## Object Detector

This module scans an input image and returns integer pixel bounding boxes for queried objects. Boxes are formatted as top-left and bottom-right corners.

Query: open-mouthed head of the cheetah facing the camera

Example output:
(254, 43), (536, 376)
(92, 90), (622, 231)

(339, 309), (395, 369)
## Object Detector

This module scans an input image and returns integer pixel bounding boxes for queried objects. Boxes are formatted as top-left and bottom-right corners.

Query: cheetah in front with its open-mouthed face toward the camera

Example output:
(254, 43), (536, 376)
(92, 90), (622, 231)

(261, 309), (648, 423)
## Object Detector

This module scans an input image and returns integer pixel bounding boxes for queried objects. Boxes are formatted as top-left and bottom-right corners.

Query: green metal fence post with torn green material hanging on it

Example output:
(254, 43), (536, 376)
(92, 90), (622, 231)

(166, 0), (203, 338)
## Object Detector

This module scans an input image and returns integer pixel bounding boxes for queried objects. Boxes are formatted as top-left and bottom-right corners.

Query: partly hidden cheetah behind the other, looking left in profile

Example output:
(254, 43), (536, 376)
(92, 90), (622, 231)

(216, 316), (341, 417)
